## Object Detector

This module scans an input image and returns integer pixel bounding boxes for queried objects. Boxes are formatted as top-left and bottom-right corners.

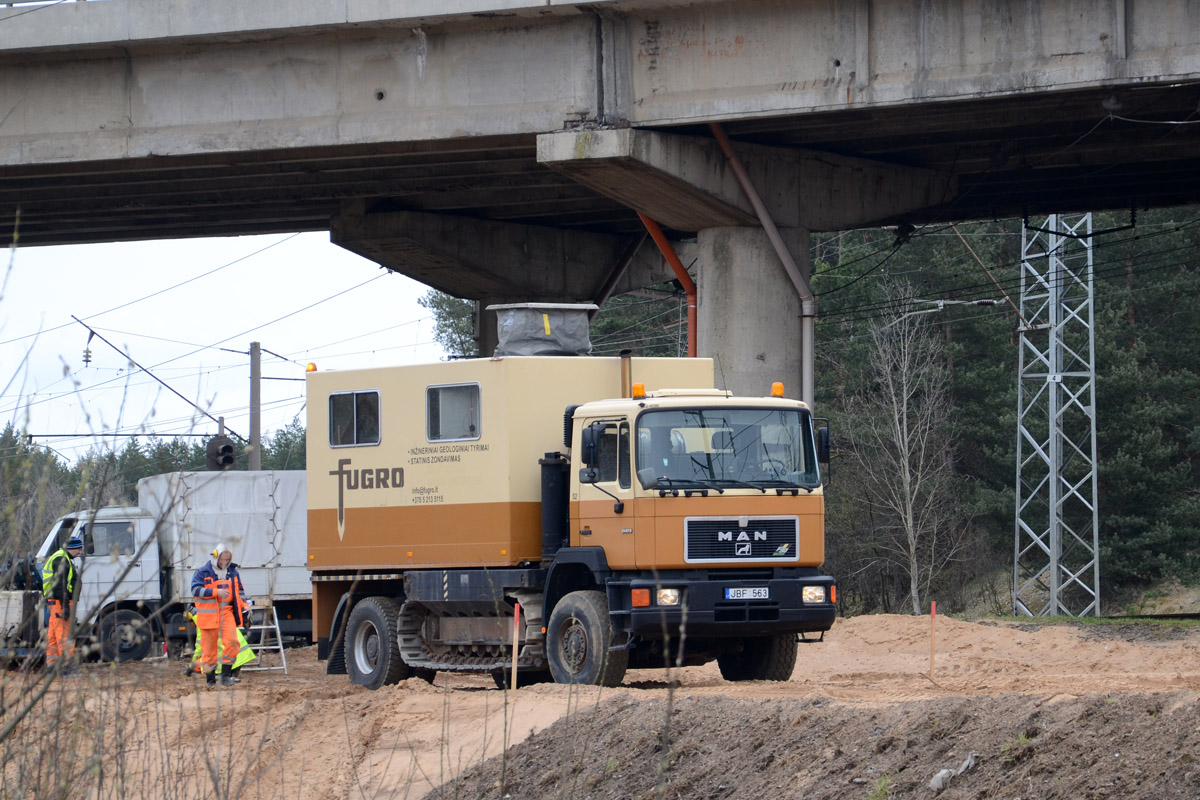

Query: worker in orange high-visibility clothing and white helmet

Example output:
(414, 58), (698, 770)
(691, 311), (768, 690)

(192, 545), (248, 686)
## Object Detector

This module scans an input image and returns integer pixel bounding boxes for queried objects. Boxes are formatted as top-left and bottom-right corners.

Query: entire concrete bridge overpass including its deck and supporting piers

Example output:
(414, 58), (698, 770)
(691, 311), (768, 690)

(0, 0), (1200, 391)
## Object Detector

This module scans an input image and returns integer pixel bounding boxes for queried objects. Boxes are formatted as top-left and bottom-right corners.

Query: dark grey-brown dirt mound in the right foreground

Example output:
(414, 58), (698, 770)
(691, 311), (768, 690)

(431, 690), (1200, 800)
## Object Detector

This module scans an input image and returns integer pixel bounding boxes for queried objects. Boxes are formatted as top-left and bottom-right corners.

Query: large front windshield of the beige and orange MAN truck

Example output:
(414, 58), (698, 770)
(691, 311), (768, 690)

(636, 408), (821, 488)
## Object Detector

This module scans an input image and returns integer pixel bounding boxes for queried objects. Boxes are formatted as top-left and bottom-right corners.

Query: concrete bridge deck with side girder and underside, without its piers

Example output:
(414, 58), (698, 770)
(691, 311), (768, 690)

(0, 0), (1200, 245)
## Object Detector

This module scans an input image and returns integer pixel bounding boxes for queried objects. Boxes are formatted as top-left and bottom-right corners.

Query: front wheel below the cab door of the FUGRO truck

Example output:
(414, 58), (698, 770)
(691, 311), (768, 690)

(547, 591), (629, 686)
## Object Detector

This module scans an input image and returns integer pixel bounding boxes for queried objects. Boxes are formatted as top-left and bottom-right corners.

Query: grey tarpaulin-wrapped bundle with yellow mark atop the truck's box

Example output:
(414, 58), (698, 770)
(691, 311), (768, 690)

(487, 302), (599, 356)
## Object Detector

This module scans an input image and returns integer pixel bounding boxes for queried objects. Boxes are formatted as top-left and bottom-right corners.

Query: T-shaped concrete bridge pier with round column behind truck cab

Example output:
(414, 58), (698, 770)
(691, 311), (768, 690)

(538, 128), (955, 403)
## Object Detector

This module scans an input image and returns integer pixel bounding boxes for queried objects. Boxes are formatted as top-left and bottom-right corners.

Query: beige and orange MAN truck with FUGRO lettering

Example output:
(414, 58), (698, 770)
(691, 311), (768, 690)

(307, 307), (836, 688)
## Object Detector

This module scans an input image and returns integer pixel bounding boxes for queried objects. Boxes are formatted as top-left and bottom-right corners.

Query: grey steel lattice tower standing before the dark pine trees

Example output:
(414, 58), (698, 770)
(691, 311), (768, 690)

(1013, 213), (1100, 616)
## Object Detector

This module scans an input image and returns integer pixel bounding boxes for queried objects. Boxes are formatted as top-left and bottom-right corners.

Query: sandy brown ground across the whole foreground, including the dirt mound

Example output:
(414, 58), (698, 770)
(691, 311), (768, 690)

(0, 615), (1200, 800)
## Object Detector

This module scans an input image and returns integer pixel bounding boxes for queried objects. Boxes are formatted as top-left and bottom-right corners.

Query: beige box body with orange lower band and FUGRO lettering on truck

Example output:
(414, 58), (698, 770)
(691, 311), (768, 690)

(307, 356), (713, 572)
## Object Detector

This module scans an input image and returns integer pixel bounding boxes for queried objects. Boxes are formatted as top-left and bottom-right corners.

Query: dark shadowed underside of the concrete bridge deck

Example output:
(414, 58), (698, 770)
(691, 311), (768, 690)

(0, 83), (1200, 246)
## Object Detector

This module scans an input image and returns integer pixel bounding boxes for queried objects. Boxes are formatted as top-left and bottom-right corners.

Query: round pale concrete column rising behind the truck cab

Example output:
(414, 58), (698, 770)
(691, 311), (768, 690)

(697, 228), (809, 398)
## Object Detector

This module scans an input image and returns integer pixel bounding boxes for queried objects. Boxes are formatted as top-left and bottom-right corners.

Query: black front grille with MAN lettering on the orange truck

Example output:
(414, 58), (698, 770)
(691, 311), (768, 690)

(684, 517), (800, 564)
